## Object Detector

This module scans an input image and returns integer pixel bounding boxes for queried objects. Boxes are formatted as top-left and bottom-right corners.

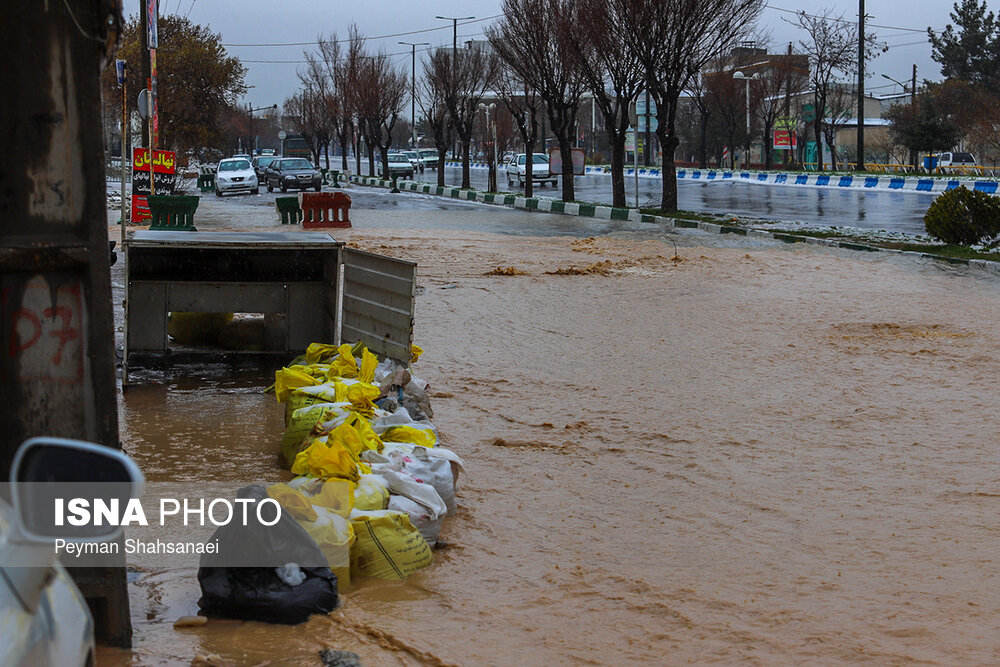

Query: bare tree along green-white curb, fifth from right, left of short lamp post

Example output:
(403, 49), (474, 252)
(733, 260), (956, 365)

(431, 47), (498, 188)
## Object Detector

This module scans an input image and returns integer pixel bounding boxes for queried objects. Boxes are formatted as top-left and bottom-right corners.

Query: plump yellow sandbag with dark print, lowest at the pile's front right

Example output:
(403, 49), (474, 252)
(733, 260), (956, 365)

(351, 510), (434, 579)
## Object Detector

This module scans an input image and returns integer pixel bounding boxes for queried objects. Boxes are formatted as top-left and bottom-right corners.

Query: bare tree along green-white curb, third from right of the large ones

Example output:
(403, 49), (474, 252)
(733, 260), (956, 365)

(487, 0), (584, 201)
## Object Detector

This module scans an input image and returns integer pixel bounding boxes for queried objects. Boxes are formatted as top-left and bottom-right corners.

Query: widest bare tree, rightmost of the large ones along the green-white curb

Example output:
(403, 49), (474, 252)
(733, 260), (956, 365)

(608, 0), (764, 211)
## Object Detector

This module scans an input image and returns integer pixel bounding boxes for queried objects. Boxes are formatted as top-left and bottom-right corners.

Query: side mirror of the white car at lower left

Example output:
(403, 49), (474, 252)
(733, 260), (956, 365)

(10, 437), (145, 544)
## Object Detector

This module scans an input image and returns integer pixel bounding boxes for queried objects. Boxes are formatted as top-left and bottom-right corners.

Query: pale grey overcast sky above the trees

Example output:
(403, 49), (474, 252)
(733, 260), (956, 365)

(160, 0), (964, 113)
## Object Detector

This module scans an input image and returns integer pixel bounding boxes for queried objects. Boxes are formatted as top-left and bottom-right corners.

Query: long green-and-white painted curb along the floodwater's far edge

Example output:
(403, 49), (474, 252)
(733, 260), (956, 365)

(350, 175), (1000, 276)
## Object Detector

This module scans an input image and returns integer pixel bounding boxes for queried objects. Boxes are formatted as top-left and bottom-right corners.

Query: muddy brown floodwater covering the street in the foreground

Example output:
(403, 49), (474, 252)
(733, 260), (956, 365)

(101, 222), (1000, 666)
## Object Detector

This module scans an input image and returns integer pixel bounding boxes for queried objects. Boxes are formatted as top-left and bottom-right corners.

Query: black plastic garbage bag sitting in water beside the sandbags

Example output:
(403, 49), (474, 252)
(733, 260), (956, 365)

(198, 485), (337, 625)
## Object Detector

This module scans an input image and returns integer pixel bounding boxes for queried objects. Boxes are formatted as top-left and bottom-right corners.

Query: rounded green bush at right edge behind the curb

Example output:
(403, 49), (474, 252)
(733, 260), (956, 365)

(924, 185), (1000, 245)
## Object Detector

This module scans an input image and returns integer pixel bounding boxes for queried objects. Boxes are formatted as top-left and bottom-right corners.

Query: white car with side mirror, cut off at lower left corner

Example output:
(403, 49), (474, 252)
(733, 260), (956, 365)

(0, 438), (143, 667)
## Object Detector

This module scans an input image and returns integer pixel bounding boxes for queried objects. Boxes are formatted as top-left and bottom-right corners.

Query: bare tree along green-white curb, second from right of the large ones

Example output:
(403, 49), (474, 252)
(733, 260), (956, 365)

(568, 0), (645, 206)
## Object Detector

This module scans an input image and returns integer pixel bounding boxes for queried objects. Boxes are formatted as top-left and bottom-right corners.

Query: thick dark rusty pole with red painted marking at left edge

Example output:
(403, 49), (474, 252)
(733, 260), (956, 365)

(0, 0), (132, 648)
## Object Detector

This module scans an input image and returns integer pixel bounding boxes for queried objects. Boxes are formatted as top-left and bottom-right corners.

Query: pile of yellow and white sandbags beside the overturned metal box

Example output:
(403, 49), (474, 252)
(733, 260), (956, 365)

(268, 343), (464, 590)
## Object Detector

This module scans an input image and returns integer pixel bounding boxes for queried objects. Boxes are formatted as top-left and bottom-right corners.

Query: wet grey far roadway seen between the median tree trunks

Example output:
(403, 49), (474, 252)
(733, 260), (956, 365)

(400, 168), (935, 234)
